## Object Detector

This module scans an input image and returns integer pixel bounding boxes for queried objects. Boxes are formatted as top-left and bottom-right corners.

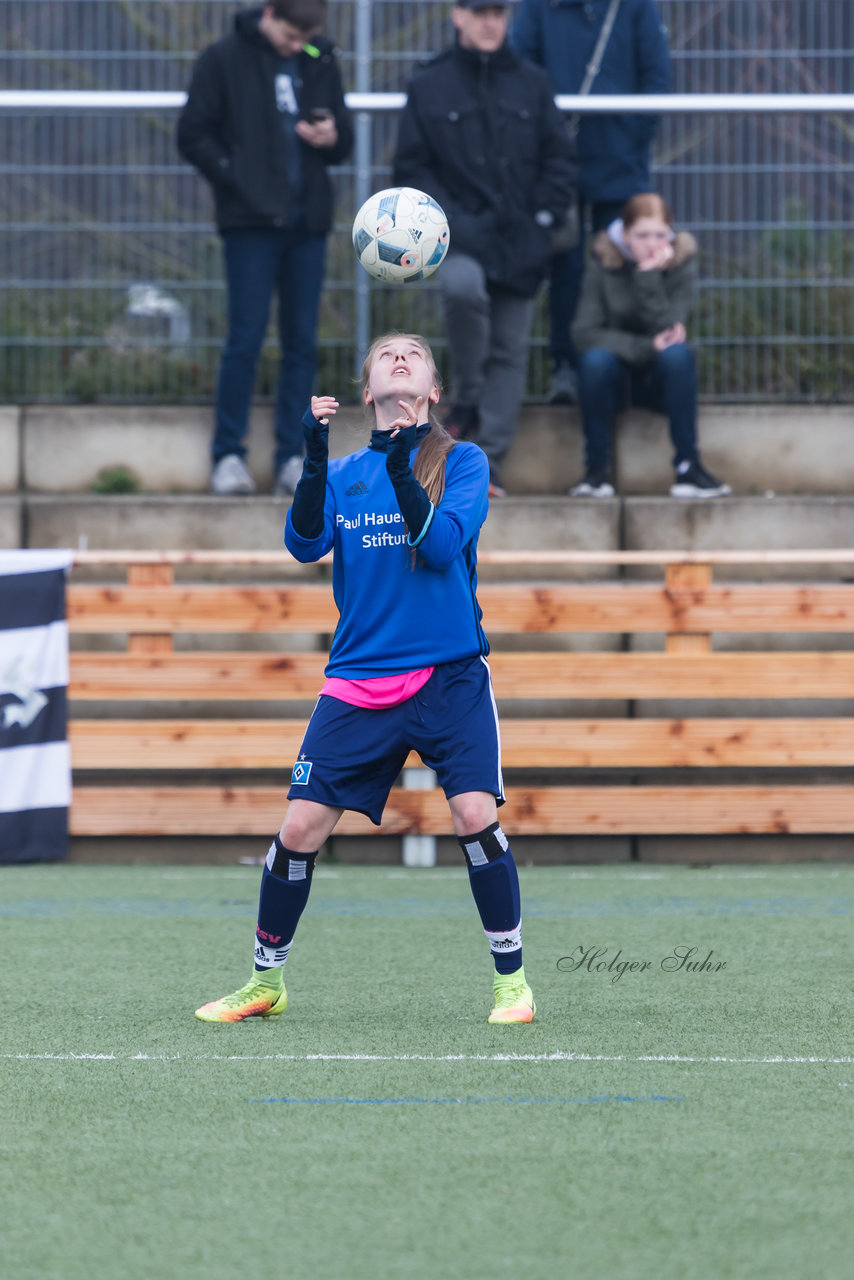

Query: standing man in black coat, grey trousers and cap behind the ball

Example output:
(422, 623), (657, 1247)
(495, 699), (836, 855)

(394, 0), (575, 497)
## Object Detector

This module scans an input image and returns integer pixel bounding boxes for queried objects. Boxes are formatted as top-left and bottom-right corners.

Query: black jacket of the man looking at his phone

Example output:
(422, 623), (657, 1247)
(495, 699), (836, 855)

(178, 9), (353, 236)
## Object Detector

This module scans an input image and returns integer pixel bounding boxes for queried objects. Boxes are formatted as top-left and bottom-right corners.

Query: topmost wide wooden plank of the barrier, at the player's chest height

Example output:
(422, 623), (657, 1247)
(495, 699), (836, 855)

(68, 582), (854, 634)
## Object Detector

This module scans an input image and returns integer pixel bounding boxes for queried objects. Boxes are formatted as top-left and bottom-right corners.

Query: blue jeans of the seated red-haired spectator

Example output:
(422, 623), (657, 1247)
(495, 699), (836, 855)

(579, 343), (698, 472)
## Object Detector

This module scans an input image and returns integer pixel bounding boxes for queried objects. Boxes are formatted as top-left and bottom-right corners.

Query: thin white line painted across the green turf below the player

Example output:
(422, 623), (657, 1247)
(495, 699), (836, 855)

(0, 1052), (854, 1066)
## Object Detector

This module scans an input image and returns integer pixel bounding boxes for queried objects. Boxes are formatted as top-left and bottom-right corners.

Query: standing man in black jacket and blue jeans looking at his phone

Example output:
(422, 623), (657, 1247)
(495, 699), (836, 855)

(178, 0), (352, 495)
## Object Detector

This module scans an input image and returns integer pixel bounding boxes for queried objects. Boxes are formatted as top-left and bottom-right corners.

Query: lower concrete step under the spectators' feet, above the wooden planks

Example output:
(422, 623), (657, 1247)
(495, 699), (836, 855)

(0, 493), (854, 580)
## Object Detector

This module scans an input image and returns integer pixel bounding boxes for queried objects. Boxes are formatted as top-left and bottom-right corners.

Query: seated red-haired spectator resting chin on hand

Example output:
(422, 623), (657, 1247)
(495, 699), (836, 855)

(570, 192), (731, 498)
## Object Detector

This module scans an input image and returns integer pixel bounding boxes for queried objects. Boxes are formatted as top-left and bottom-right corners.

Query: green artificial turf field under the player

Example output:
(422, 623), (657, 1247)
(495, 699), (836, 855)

(0, 865), (854, 1280)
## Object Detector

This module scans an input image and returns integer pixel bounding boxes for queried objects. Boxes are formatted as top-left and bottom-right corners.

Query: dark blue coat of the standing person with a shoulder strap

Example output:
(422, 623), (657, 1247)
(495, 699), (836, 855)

(511, 0), (670, 204)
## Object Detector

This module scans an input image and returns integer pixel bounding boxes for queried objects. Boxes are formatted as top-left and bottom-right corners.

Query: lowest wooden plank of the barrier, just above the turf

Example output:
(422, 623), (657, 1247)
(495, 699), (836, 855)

(69, 786), (854, 840)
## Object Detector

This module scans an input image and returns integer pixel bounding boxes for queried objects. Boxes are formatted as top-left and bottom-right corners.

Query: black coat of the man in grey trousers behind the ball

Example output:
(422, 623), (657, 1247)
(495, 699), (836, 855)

(393, 44), (575, 297)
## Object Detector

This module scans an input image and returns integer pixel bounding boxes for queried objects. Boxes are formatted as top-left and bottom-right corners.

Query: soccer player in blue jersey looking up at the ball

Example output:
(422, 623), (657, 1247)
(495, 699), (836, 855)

(196, 334), (534, 1023)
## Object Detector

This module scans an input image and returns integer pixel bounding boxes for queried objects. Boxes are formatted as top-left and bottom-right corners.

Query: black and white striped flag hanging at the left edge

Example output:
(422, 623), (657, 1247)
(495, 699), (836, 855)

(0, 550), (73, 863)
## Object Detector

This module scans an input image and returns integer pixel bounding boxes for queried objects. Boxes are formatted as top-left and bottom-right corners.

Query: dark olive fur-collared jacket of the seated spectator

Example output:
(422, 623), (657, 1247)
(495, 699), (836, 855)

(572, 232), (698, 365)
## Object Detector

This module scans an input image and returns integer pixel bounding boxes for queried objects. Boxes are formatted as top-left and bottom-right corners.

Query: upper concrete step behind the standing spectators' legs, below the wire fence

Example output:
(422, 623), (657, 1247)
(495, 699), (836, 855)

(0, 404), (854, 497)
